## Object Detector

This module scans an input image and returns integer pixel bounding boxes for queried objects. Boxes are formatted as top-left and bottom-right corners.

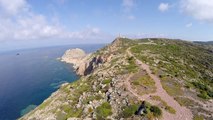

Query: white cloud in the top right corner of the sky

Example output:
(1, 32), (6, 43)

(181, 0), (213, 22)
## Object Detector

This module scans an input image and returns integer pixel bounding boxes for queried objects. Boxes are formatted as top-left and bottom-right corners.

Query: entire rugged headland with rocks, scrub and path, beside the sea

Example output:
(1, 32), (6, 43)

(20, 38), (213, 120)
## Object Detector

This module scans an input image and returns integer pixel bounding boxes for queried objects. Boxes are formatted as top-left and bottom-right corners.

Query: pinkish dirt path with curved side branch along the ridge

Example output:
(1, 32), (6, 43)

(125, 48), (193, 120)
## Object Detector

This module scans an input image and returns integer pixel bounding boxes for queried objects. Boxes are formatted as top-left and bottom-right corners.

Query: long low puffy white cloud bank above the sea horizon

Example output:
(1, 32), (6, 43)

(0, 15), (104, 41)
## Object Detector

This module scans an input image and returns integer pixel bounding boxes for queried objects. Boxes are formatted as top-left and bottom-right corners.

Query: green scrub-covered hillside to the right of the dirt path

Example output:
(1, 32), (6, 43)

(131, 38), (213, 119)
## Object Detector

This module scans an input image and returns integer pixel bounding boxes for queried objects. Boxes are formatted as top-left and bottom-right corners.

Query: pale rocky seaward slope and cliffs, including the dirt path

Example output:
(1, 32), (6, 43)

(20, 38), (213, 120)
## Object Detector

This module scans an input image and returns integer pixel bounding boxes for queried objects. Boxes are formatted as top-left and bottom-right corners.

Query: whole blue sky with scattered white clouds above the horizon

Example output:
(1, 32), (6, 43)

(0, 0), (213, 51)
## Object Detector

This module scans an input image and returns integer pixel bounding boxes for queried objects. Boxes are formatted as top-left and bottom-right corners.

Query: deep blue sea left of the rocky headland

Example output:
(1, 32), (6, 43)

(0, 44), (104, 120)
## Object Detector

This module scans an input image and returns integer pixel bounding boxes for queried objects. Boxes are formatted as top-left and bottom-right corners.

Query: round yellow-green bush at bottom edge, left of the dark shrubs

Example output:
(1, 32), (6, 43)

(96, 102), (112, 119)
